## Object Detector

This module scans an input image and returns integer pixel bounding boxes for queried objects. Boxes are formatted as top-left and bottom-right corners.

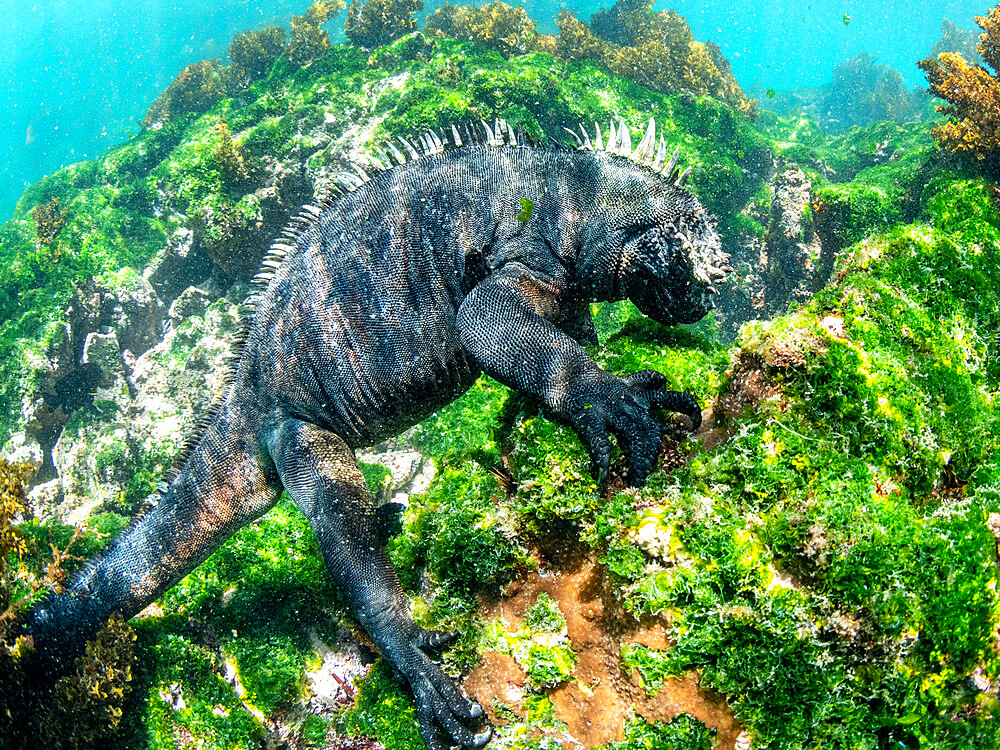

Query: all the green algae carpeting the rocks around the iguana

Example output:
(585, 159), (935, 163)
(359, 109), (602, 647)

(0, 13), (1000, 750)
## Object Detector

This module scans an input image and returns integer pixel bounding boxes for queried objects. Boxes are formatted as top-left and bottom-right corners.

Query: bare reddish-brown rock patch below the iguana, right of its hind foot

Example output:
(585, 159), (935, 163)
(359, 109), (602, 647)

(464, 556), (742, 748)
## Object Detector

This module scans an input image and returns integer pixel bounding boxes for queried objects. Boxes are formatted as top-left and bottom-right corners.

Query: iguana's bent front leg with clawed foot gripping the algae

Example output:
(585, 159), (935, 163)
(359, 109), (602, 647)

(456, 264), (701, 484)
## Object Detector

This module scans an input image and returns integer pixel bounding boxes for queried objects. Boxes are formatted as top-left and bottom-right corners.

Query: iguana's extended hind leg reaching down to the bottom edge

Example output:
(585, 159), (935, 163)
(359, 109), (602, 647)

(267, 418), (491, 750)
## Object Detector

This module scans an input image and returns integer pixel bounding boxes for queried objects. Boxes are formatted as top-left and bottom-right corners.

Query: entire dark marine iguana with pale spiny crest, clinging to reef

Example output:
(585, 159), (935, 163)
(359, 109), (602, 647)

(26, 120), (731, 750)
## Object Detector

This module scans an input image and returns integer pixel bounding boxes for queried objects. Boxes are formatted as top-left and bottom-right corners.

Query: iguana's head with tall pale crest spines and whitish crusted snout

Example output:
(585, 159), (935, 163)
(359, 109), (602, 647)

(577, 120), (732, 325)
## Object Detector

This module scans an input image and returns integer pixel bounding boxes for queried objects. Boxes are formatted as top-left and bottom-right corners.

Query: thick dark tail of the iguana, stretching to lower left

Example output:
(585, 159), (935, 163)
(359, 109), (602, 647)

(27, 406), (280, 671)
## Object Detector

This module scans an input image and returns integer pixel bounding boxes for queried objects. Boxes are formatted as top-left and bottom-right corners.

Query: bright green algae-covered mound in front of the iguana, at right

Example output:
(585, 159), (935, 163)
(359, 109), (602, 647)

(592, 180), (1000, 747)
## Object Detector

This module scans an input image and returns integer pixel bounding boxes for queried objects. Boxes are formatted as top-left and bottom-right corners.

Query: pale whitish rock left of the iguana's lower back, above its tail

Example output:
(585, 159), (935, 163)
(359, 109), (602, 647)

(39, 288), (242, 523)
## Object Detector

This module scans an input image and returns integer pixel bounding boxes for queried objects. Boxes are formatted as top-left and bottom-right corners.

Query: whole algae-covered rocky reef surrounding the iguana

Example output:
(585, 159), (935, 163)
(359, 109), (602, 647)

(0, 0), (1000, 750)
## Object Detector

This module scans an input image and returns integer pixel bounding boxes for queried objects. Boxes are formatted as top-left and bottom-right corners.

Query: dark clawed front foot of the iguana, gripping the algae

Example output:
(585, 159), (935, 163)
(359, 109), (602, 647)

(565, 370), (701, 485)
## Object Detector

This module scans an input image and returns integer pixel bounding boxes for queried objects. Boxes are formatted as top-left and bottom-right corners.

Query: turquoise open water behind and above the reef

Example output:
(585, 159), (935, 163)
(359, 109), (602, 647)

(0, 0), (988, 219)
